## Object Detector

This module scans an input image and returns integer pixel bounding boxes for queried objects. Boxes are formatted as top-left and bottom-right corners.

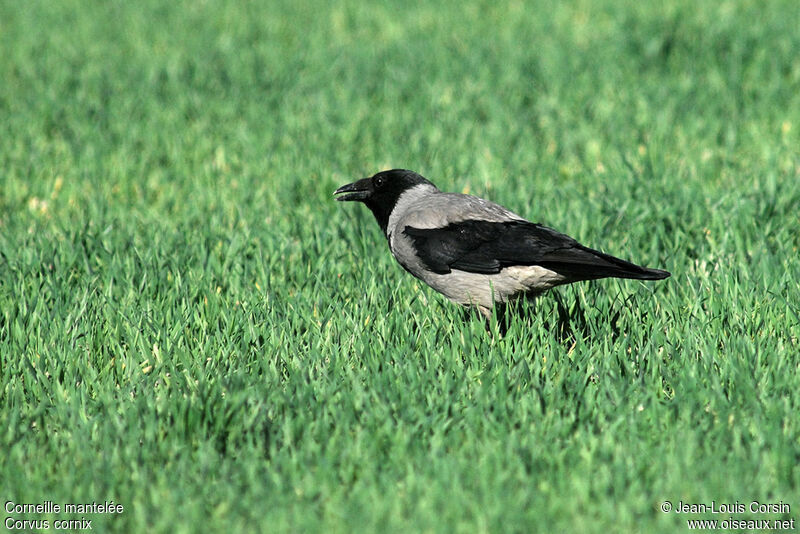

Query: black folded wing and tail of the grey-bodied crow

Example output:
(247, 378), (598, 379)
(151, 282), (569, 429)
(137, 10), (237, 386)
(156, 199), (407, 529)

(403, 220), (669, 280)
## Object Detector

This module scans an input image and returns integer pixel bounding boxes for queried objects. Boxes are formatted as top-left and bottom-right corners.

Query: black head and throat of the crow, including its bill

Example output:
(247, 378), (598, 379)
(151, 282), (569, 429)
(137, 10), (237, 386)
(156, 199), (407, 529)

(334, 169), (435, 233)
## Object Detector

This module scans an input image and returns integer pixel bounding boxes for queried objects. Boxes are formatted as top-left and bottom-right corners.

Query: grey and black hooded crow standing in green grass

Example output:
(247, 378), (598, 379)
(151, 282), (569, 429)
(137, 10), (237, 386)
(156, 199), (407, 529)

(334, 169), (670, 319)
